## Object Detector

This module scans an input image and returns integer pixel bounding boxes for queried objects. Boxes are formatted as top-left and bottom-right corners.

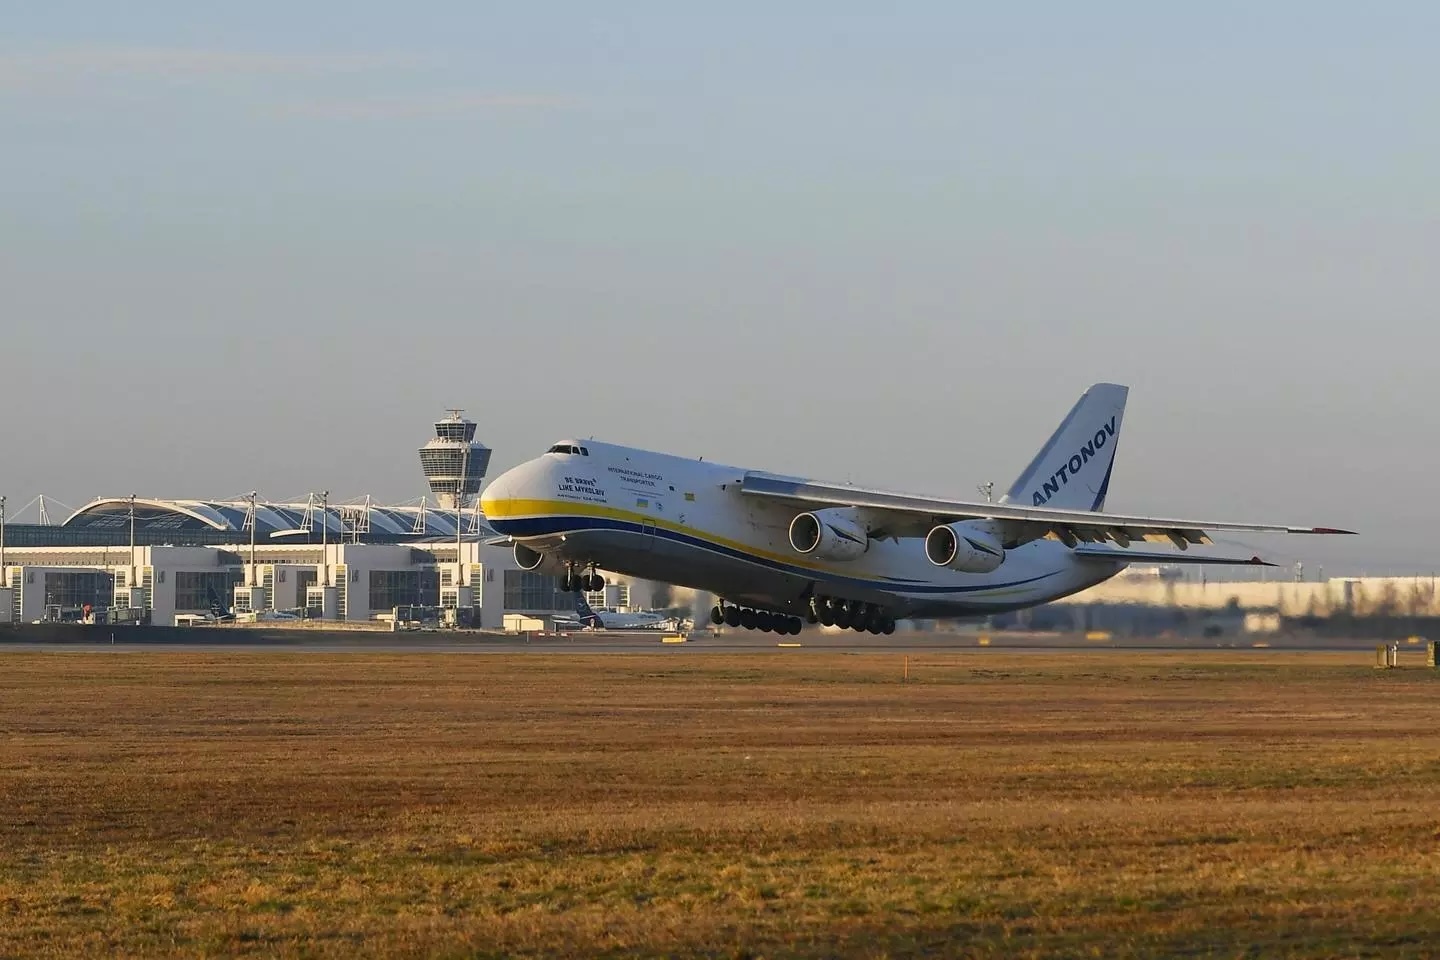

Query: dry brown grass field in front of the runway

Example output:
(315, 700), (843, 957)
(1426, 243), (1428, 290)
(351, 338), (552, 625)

(0, 651), (1440, 957)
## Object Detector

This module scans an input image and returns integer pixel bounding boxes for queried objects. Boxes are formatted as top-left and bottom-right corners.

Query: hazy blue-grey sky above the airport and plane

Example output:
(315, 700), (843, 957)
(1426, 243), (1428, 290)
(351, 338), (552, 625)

(0, 0), (1440, 571)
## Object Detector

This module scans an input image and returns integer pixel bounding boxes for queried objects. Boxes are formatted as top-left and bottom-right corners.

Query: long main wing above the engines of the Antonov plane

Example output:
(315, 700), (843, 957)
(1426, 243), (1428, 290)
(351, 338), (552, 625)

(740, 471), (1354, 550)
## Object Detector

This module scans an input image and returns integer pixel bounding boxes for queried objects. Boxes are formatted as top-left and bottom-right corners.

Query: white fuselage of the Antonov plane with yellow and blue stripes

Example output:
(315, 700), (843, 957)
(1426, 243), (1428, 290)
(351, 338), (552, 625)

(481, 440), (1125, 617)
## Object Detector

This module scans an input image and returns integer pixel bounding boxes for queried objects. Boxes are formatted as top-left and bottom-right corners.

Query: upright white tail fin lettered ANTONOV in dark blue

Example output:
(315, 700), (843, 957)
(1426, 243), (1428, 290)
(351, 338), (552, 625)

(1002, 383), (1130, 511)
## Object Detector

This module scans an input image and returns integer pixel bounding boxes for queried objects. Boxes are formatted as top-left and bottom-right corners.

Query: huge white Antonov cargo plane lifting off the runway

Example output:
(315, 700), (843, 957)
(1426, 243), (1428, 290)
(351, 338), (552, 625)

(481, 383), (1349, 633)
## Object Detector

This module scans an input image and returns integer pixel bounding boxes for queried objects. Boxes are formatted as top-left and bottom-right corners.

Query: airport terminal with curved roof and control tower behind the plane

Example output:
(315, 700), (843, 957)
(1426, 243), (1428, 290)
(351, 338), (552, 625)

(0, 410), (645, 629)
